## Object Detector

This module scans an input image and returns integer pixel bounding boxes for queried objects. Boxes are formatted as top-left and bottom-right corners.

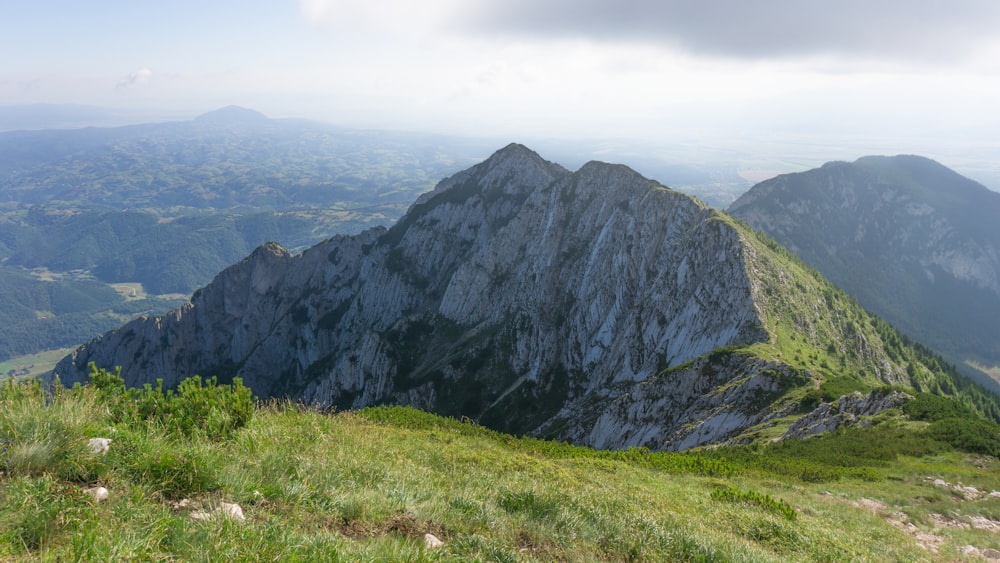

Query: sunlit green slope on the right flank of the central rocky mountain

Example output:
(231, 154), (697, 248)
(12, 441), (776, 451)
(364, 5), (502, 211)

(720, 216), (1000, 422)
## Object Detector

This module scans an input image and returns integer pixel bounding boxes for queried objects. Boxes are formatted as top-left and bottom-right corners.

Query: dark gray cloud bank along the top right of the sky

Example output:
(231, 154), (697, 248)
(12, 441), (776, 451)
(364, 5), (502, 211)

(460, 0), (1000, 62)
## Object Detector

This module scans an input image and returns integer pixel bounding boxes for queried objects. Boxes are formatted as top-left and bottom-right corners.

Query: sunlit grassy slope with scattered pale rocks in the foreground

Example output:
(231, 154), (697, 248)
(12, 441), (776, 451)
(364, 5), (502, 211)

(0, 376), (1000, 561)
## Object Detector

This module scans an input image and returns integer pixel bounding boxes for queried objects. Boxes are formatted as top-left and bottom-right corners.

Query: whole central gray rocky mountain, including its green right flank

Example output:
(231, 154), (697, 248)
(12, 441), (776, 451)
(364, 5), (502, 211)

(55, 145), (998, 449)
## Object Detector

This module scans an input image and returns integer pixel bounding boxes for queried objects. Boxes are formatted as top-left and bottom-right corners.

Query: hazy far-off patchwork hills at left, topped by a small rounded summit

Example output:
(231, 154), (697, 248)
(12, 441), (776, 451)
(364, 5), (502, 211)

(0, 107), (488, 213)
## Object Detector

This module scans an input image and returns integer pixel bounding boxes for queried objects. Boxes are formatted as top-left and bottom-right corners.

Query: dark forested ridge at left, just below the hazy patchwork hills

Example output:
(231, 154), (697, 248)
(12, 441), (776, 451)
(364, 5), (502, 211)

(0, 205), (399, 294)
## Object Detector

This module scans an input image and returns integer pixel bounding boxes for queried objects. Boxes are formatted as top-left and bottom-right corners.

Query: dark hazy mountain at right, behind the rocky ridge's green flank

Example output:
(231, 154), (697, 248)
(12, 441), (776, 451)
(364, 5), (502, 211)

(729, 156), (1000, 386)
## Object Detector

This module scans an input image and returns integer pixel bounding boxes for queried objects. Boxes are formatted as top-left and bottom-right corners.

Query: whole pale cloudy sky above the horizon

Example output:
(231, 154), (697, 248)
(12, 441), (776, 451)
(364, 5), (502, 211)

(0, 0), (1000, 175)
